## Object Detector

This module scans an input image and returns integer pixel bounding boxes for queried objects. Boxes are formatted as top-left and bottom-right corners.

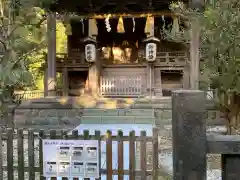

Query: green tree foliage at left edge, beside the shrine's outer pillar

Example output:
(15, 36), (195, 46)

(0, 0), (46, 109)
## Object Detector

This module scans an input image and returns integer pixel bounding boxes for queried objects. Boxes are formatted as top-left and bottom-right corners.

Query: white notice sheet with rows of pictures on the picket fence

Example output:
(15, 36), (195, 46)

(43, 139), (99, 178)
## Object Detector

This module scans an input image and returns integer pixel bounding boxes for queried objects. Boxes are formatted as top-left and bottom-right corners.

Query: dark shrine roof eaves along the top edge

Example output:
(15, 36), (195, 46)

(50, 0), (188, 15)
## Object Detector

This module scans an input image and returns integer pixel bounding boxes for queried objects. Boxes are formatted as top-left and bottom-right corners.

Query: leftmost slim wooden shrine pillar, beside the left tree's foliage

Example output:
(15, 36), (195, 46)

(47, 13), (56, 96)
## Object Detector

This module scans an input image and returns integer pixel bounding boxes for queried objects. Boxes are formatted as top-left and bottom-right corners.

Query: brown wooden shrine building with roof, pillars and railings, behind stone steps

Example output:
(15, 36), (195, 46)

(45, 0), (198, 97)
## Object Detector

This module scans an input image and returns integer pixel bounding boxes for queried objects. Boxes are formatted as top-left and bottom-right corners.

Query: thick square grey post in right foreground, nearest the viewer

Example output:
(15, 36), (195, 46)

(172, 90), (207, 180)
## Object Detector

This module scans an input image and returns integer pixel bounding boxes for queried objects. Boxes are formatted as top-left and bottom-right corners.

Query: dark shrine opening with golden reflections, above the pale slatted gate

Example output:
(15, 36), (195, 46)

(97, 18), (146, 64)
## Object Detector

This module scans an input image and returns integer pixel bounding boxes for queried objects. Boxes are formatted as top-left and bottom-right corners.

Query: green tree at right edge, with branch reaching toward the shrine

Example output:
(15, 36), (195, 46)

(165, 0), (240, 132)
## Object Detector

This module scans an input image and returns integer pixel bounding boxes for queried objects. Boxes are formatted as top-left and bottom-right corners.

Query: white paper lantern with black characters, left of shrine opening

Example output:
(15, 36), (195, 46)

(83, 37), (97, 63)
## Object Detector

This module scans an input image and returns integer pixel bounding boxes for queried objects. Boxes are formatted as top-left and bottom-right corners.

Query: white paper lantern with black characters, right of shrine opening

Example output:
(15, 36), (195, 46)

(143, 36), (160, 62)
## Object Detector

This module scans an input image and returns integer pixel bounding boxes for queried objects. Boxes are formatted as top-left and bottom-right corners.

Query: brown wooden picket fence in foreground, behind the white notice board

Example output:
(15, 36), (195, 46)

(0, 128), (169, 180)
